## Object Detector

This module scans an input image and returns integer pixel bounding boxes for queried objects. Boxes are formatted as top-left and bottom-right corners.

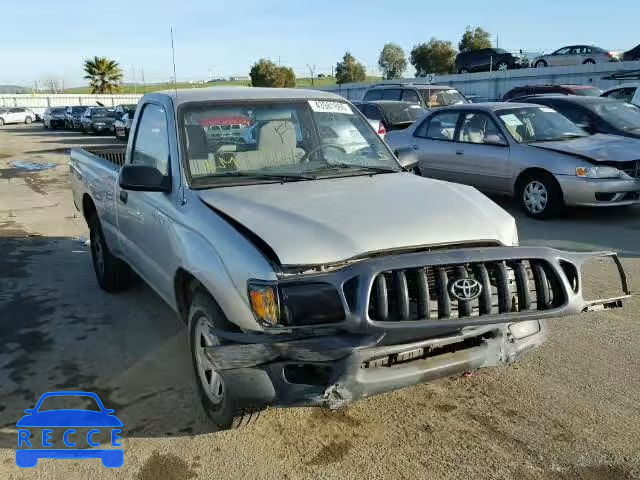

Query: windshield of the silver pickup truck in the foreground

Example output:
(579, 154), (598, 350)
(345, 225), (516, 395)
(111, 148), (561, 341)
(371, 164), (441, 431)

(179, 100), (400, 188)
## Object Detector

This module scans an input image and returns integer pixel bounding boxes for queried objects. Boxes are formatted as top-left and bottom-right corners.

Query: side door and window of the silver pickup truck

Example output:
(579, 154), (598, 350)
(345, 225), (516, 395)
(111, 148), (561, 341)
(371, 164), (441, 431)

(116, 103), (175, 298)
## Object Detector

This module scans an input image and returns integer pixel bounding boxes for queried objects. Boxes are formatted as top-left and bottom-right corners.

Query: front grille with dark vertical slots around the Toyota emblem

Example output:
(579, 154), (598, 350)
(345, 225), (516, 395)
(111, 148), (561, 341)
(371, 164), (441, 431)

(368, 260), (565, 321)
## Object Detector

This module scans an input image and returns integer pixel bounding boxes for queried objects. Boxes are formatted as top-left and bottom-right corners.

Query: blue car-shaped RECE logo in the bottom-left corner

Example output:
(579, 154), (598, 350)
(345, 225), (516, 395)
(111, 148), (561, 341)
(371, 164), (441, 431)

(16, 392), (124, 468)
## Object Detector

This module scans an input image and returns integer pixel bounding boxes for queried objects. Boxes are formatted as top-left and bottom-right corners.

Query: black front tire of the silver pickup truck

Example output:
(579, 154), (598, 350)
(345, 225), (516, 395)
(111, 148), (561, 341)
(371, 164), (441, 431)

(187, 290), (264, 430)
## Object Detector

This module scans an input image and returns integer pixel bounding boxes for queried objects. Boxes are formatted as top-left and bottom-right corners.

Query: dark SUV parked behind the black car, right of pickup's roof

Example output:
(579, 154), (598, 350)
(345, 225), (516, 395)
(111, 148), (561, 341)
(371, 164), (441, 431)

(362, 83), (467, 108)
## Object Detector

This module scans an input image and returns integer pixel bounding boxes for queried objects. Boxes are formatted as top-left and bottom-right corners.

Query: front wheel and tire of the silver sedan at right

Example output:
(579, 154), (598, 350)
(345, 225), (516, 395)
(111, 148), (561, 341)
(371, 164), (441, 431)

(516, 173), (564, 220)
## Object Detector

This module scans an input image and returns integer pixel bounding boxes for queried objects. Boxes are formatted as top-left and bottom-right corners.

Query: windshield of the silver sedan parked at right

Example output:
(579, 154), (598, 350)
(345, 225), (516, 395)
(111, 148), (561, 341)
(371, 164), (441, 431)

(496, 107), (587, 143)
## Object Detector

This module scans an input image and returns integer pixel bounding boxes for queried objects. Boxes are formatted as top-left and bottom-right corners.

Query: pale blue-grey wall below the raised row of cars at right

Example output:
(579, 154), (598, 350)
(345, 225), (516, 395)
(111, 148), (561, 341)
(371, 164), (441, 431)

(319, 62), (640, 101)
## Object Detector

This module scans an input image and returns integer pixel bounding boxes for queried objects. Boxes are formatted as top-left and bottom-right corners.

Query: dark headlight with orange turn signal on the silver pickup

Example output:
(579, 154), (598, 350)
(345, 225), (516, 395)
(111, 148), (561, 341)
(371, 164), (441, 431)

(249, 282), (345, 327)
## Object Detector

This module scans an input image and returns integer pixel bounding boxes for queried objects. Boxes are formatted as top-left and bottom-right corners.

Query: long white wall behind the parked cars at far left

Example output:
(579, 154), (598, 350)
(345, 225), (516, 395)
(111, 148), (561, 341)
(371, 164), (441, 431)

(0, 93), (142, 115)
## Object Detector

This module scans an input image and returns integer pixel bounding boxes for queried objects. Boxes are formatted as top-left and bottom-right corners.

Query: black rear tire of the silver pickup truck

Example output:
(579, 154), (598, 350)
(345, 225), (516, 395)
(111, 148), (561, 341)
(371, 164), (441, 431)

(87, 213), (131, 293)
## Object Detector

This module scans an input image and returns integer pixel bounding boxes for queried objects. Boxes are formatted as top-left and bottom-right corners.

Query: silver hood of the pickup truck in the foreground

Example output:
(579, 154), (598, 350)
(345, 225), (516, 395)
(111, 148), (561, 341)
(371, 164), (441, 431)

(199, 173), (517, 265)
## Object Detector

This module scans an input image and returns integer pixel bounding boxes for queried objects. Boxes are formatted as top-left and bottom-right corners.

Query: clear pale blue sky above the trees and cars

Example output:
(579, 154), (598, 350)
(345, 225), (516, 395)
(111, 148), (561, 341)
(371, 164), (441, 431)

(0, 0), (640, 87)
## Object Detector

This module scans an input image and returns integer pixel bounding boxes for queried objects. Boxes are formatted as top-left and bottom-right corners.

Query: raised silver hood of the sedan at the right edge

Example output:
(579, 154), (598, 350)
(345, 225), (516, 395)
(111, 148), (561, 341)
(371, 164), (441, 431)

(531, 133), (640, 162)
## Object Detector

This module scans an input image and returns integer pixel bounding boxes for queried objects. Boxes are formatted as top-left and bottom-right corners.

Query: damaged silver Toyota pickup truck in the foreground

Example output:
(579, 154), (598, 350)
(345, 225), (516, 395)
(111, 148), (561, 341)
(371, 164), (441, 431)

(70, 88), (628, 428)
